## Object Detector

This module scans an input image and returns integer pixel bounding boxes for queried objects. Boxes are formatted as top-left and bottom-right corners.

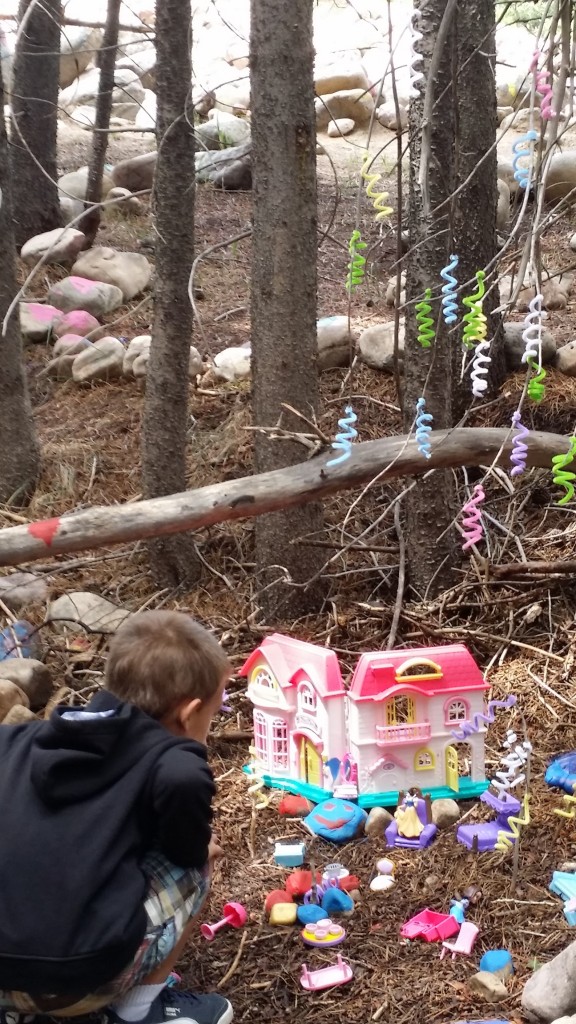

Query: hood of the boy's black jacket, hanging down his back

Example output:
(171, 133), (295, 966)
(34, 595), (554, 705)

(30, 690), (177, 807)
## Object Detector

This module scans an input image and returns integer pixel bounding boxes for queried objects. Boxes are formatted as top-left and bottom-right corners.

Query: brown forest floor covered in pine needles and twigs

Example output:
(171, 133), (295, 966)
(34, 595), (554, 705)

(8, 130), (576, 1024)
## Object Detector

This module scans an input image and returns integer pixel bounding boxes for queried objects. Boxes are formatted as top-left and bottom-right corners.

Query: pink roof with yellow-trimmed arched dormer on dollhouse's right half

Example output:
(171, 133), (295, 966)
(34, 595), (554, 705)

(348, 643), (489, 700)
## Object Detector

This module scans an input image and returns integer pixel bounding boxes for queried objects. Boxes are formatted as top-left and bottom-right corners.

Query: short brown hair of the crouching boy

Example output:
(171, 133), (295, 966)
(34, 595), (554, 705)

(106, 611), (232, 719)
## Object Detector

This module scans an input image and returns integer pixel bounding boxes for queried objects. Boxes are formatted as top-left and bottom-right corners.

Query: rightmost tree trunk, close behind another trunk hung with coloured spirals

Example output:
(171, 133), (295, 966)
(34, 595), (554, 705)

(452, 0), (506, 419)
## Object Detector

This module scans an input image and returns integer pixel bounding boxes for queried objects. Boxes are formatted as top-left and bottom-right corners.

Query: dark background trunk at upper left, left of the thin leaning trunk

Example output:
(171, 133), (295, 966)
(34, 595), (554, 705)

(10, 0), (61, 248)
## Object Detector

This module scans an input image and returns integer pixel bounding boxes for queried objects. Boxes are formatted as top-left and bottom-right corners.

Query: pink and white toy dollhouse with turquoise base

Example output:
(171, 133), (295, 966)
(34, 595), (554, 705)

(241, 633), (488, 807)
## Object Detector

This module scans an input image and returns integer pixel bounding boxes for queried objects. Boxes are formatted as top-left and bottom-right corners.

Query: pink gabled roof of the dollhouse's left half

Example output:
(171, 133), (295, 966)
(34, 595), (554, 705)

(240, 633), (344, 697)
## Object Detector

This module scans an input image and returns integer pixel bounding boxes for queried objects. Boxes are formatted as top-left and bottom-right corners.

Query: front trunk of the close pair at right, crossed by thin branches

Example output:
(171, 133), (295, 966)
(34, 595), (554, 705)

(404, 0), (459, 596)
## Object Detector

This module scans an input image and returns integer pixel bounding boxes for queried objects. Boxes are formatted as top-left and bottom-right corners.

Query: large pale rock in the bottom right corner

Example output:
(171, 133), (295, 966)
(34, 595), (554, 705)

(522, 942), (576, 1024)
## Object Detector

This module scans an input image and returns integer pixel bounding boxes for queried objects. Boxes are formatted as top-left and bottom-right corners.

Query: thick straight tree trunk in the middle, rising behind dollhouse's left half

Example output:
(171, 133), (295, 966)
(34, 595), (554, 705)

(250, 0), (323, 620)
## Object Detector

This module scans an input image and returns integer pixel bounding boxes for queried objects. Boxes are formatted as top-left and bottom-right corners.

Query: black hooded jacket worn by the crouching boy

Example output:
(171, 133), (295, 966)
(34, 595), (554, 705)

(0, 690), (214, 994)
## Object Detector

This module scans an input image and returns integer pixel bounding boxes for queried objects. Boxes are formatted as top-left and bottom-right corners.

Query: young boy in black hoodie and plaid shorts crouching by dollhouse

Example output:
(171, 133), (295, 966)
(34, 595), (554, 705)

(0, 611), (233, 1024)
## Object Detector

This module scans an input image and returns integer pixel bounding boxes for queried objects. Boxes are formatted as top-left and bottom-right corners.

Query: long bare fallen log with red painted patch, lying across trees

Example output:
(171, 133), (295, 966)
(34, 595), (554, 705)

(0, 427), (570, 565)
